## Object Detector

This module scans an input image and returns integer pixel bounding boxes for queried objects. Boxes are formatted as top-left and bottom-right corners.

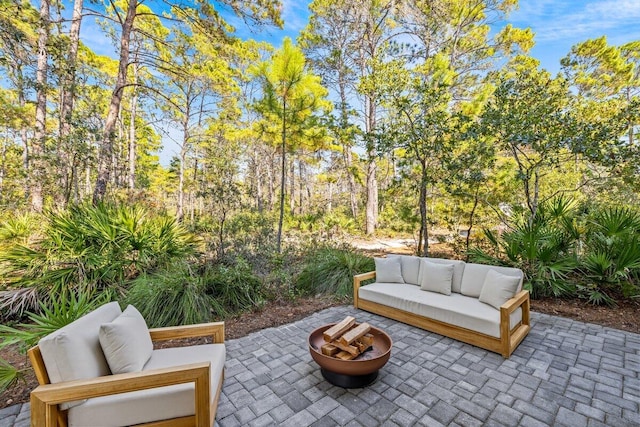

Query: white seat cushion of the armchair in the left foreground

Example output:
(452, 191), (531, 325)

(68, 344), (226, 427)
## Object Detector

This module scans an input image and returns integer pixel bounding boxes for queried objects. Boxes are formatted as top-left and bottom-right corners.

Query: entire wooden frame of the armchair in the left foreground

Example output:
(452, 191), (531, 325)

(28, 322), (224, 427)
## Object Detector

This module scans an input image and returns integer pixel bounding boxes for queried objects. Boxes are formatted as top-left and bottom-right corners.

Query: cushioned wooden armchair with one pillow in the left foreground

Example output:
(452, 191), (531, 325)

(29, 302), (226, 427)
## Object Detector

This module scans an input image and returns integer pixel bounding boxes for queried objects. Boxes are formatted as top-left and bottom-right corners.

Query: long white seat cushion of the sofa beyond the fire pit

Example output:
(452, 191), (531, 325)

(358, 283), (522, 338)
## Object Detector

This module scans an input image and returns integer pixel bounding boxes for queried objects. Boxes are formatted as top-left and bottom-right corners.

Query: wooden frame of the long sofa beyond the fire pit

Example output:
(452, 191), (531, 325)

(353, 271), (530, 359)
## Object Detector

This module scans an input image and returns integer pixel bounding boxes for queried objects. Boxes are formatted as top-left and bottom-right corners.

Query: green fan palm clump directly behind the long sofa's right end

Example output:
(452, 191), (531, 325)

(469, 198), (577, 298)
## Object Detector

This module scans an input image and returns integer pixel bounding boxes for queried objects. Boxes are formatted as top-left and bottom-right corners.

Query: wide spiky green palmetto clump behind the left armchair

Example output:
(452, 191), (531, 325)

(0, 204), (197, 320)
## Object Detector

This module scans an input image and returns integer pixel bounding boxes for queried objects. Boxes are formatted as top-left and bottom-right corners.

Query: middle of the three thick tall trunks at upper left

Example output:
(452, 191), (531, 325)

(59, 0), (83, 205)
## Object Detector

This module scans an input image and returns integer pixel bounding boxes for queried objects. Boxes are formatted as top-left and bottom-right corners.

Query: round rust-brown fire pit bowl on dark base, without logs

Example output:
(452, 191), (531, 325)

(309, 323), (392, 388)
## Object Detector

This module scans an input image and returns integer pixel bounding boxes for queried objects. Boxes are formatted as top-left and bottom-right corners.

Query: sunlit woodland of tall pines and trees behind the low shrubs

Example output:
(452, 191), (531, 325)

(0, 0), (640, 253)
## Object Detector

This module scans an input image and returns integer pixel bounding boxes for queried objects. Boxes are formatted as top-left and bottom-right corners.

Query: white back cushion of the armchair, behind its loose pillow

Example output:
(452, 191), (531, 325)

(38, 302), (122, 409)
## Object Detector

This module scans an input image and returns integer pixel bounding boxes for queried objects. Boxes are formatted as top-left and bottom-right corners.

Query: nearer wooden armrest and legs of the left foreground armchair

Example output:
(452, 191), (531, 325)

(31, 362), (211, 426)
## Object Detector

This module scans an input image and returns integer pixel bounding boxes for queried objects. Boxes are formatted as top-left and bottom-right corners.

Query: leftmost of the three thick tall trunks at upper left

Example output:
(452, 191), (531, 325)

(30, 0), (50, 212)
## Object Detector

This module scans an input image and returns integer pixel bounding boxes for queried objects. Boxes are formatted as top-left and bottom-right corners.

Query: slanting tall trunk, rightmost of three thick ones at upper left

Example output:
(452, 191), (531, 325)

(93, 0), (138, 204)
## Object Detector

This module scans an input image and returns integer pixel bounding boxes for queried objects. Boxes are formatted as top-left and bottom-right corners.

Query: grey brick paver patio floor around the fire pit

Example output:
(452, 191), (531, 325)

(0, 306), (640, 427)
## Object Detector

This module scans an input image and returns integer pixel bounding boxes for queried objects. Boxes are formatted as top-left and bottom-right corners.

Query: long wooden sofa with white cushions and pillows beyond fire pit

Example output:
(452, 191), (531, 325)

(353, 255), (530, 358)
